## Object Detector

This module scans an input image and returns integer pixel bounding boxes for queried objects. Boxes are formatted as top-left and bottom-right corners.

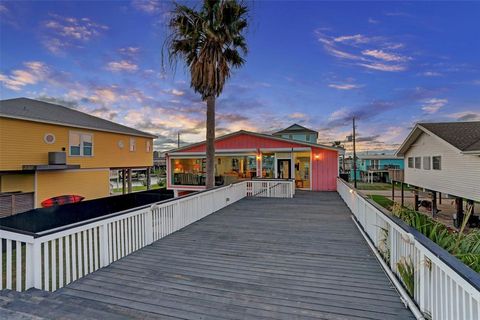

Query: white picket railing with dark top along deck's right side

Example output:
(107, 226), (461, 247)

(337, 179), (480, 320)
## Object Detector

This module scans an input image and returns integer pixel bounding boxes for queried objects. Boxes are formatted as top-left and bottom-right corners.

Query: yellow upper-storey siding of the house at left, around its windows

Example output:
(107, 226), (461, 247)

(0, 118), (153, 171)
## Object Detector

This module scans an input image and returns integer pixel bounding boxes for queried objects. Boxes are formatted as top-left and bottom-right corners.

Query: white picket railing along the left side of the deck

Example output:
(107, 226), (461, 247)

(0, 180), (295, 291)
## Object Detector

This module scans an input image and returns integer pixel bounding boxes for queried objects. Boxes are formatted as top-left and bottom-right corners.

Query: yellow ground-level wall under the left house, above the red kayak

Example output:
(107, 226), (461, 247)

(36, 169), (110, 207)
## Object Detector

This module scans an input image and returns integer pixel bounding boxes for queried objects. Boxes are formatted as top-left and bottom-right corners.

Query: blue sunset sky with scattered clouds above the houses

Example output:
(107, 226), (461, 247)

(0, 0), (480, 152)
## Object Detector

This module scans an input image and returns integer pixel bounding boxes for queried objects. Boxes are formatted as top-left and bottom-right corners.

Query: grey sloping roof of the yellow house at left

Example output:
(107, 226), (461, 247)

(0, 98), (156, 139)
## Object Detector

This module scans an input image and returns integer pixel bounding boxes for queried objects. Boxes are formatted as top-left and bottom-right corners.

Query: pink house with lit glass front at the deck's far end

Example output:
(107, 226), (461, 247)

(166, 130), (343, 194)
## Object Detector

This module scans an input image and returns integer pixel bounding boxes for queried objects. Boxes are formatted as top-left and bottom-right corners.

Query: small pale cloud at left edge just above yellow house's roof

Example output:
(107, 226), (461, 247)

(0, 61), (50, 91)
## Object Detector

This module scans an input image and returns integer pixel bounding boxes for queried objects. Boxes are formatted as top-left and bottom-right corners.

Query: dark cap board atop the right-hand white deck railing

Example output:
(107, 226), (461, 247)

(338, 179), (480, 290)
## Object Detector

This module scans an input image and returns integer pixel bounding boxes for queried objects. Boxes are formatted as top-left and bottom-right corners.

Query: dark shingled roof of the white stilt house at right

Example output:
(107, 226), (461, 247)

(397, 121), (480, 155)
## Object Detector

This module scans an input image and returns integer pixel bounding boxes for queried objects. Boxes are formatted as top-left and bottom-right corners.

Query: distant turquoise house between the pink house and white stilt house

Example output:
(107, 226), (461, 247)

(350, 154), (404, 183)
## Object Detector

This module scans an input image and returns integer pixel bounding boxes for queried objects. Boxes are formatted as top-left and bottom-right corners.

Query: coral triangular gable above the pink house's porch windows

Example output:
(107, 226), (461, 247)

(178, 134), (305, 152)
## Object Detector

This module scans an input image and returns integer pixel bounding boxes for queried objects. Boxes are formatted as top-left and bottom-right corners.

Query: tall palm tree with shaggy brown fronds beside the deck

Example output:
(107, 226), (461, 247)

(165, 0), (248, 189)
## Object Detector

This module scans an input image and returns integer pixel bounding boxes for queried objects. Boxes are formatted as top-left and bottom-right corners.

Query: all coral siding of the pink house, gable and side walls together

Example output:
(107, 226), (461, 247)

(171, 134), (338, 191)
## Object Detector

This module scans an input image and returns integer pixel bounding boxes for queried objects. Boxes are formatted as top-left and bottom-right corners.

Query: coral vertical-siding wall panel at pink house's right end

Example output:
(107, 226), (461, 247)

(312, 148), (338, 191)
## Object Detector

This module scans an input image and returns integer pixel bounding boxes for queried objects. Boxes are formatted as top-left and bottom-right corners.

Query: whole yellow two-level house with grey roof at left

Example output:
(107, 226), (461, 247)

(0, 98), (156, 212)
